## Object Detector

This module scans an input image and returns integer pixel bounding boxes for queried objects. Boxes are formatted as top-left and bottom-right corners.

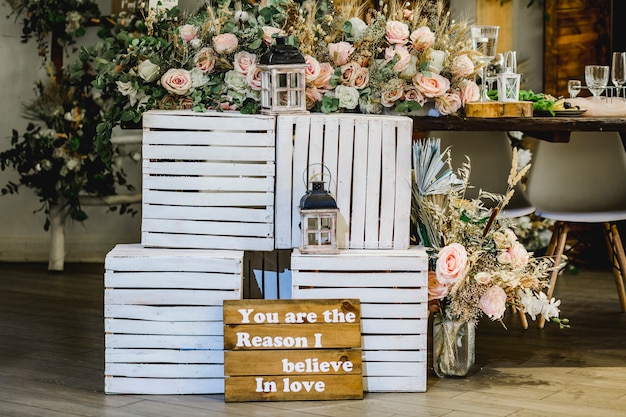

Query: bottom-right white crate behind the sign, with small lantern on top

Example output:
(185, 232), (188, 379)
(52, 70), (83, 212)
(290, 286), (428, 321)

(291, 248), (428, 392)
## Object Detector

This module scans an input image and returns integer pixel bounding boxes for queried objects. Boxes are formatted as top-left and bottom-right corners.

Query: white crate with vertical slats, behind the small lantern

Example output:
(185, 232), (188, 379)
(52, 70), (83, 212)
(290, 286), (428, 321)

(275, 114), (413, 249)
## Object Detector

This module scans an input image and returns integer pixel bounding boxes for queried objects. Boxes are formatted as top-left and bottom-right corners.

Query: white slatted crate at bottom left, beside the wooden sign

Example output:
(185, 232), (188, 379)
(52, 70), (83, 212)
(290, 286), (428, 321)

(104, 245), (243, 394)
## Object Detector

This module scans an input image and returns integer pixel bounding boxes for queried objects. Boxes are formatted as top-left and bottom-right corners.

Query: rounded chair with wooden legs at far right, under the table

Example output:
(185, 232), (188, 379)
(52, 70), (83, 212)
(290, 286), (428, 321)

(527, 132), (626, 327)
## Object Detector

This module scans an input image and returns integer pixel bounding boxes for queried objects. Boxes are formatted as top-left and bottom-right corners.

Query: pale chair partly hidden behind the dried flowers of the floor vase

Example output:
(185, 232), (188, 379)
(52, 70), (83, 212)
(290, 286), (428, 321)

(427, 131), (534, 218)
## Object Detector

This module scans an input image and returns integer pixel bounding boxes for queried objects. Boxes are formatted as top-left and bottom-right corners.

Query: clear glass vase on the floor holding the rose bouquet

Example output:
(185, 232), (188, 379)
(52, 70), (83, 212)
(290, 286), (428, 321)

(433, 315), (476, 378)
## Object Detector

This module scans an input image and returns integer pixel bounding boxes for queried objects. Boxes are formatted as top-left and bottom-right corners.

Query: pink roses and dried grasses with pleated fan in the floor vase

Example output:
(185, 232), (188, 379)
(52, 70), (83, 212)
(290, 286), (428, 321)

(413, 139), (567, 326)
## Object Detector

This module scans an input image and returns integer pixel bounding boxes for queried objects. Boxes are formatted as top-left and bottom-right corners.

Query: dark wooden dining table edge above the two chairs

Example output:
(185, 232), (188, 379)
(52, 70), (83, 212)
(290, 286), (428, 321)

(412, 116), (626, 142)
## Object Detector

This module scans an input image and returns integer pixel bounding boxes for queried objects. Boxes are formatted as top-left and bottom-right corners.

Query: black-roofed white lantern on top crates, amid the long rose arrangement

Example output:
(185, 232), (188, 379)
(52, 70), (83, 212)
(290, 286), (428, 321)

(259, 37), (308, 114)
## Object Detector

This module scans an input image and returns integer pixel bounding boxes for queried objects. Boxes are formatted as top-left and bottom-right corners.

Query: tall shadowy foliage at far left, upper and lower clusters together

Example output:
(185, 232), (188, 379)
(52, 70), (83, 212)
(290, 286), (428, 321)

(0, 0), (138, 230)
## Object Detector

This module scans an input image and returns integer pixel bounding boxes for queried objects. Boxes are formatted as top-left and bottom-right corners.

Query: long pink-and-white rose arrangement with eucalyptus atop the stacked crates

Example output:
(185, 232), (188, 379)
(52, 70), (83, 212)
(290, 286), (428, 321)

(73, 0), (479, 145)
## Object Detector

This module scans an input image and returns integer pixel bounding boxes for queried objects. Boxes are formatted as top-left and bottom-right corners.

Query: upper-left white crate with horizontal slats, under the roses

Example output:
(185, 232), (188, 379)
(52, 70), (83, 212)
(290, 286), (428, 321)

(141, 110), (276, 250)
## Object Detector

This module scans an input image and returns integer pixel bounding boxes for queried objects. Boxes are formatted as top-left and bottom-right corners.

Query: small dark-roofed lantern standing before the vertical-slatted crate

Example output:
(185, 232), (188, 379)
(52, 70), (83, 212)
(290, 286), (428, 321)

(300, 181), (339, 253)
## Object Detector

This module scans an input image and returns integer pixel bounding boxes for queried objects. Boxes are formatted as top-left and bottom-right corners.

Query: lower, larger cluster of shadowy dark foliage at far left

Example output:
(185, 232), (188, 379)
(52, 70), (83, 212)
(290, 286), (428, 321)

(0, 69), (137, 230)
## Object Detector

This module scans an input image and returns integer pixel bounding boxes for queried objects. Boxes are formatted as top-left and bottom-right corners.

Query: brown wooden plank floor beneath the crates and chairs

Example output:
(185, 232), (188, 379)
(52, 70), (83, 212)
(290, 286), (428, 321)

(0, 263), (626, 417)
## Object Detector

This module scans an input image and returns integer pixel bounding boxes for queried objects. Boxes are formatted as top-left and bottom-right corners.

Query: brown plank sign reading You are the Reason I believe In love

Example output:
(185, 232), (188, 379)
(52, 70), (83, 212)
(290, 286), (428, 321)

(224, 299), (363, 402)
